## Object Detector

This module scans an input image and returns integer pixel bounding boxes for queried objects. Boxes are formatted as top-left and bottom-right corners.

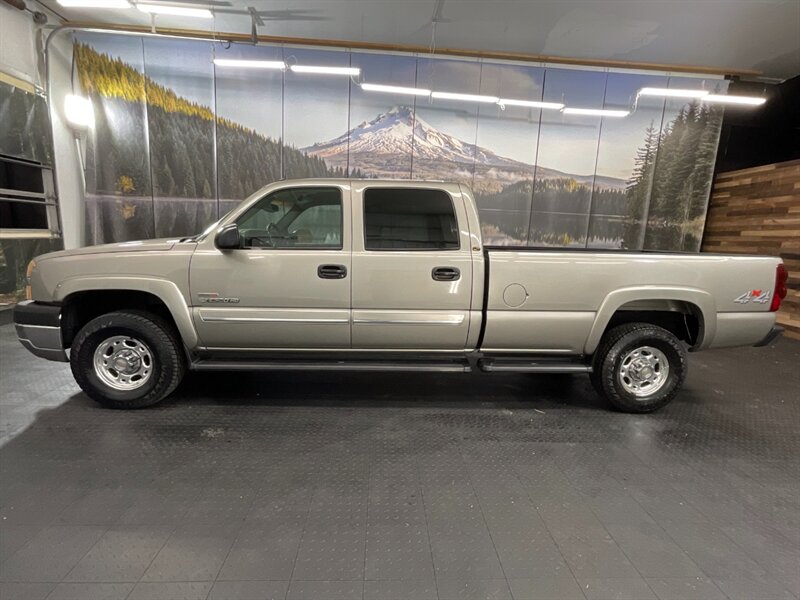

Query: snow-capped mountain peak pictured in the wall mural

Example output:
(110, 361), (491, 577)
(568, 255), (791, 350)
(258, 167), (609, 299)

(301, 106), (626, 192)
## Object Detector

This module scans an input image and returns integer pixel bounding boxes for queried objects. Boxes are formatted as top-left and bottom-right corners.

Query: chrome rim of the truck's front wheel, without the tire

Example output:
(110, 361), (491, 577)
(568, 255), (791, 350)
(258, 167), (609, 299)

(94, 335), (153, 391)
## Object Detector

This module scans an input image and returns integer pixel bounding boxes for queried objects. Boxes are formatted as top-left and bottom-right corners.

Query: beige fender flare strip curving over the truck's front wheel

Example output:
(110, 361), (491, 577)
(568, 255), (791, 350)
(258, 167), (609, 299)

(53, 275), (198, 348)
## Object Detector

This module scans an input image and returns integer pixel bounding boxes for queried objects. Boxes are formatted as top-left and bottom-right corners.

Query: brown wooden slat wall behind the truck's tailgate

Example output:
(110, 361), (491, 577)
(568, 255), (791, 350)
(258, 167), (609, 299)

(703, 160), (800, 339)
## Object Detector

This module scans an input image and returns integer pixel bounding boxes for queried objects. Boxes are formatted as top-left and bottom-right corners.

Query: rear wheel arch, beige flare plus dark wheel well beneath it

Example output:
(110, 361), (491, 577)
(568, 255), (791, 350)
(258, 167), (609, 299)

(584, 286), (716, 355)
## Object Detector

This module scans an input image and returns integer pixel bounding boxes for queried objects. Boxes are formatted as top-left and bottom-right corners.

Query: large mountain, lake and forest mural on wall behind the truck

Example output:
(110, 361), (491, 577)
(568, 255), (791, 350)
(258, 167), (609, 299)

(75, 34), (726, 251)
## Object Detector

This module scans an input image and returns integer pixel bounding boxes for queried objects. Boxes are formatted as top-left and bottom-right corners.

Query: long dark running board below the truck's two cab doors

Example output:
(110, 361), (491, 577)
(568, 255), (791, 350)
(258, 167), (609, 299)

(189, 359), (472, 373)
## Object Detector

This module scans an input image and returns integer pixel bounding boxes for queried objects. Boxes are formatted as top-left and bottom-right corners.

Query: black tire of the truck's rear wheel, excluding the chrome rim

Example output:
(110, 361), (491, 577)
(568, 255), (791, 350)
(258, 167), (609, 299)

(591, 323), (688, 413)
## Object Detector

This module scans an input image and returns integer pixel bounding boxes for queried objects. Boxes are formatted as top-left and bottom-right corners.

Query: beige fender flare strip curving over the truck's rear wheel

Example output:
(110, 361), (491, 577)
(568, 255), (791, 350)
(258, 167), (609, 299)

(584, 285), (717, 354)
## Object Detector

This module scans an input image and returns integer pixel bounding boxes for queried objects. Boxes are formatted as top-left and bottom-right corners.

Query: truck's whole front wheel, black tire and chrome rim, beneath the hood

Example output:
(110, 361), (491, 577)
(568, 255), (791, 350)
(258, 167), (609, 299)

(70, 310), (185, 409)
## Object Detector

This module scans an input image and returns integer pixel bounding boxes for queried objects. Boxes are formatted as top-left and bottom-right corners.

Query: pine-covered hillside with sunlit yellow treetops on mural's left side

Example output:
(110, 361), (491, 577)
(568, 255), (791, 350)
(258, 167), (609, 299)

(74, 43), (345, 239)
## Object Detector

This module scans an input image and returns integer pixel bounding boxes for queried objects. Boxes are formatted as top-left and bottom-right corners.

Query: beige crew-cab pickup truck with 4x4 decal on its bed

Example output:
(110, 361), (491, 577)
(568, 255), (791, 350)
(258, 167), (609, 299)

(14, 179), (787, 412)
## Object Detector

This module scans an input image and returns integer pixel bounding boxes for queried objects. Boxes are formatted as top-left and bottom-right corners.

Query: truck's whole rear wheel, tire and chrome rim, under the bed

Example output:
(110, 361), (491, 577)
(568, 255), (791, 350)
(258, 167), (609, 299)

(591, 323), (688, 413)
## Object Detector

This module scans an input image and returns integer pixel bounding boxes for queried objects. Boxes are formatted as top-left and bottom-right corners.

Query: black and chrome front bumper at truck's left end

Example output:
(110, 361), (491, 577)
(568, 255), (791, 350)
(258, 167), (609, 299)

(14, 300), (69, 362)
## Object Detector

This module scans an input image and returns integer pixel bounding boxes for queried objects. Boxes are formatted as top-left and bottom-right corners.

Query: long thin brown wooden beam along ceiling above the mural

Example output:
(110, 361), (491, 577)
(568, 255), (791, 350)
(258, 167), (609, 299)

(63, 21), (761, 77)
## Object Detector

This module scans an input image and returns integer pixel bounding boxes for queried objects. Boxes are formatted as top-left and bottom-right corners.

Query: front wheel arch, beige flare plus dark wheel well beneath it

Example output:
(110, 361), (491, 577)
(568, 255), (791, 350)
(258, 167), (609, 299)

(54, 277), (197, 349)
